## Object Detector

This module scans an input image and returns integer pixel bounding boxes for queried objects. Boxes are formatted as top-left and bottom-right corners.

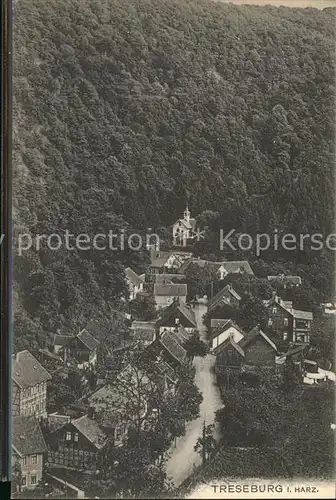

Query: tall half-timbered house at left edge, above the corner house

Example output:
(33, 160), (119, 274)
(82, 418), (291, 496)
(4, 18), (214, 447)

(12, 351), (51, 419)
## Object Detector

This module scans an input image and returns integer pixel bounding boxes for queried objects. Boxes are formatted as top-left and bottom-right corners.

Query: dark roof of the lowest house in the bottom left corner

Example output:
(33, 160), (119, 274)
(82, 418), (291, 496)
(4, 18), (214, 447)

(12, 415), (47, 456)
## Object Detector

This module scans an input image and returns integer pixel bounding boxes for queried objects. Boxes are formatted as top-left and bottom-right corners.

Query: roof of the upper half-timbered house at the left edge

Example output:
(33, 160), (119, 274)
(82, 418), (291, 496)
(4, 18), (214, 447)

(12, 351), (51, 388)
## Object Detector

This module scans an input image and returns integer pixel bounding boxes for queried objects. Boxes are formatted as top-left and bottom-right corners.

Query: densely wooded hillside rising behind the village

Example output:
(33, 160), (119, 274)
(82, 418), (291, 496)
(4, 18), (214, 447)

(13, 0), (335, 347)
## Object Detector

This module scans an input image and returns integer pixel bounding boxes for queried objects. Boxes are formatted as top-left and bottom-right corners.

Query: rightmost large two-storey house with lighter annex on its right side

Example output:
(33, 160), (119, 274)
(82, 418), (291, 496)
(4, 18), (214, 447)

(264, 293), (313, 343)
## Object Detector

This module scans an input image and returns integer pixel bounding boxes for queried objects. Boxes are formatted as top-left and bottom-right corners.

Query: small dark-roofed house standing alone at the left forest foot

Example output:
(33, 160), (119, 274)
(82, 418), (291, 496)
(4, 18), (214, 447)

(60, 328), (99, 369)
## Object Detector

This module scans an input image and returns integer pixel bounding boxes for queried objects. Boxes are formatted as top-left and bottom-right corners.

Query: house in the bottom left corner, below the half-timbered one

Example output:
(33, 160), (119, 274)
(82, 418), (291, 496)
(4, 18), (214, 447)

(12, 415), (47, 491)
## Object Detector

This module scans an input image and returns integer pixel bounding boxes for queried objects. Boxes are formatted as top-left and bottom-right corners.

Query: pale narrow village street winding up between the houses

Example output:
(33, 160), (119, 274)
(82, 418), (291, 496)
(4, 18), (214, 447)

(166, 303), (223, 486)
